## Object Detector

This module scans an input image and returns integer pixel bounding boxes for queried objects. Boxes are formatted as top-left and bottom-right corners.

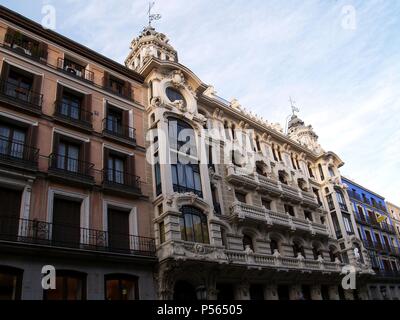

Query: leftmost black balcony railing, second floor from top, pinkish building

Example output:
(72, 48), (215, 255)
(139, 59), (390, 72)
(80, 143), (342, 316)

(0, 80), (43, 112)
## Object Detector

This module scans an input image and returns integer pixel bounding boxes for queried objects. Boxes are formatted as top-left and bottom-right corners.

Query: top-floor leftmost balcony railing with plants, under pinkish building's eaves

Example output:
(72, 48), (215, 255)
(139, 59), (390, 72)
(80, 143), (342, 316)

(4, 33), (47, 62)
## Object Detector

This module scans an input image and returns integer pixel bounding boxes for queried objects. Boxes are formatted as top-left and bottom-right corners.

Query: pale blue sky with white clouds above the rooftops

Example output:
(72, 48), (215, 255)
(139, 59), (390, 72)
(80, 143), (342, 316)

(0, 0), (400, 205)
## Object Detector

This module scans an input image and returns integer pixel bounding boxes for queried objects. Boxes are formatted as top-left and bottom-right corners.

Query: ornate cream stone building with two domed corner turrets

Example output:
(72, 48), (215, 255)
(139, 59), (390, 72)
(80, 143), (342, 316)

(125, 27), (373, 300)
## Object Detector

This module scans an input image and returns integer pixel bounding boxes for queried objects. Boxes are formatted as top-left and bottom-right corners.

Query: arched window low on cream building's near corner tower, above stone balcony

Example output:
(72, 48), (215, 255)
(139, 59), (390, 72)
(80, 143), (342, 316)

(180, 206), (210, 243)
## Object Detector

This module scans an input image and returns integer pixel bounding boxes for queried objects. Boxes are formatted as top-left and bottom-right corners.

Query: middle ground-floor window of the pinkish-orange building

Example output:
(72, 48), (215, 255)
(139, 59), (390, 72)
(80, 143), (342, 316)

(43, 270), (86, 300)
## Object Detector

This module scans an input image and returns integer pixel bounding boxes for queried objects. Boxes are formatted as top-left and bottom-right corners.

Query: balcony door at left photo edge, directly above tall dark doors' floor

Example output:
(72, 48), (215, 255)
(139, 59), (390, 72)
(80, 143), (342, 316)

(0, 124), (26, 159)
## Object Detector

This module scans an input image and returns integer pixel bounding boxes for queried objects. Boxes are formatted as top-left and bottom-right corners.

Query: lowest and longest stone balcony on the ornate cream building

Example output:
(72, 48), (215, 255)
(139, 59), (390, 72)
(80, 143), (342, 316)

(158, 240), (343, 273)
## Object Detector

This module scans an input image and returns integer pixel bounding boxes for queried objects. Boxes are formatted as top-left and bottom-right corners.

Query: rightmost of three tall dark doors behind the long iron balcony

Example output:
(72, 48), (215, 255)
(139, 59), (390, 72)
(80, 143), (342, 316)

(108, 208), (130, 251)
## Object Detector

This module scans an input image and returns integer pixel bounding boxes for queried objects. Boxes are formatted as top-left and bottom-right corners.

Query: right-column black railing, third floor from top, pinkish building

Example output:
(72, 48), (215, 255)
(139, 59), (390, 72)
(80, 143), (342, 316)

(103, 169), (141, 193)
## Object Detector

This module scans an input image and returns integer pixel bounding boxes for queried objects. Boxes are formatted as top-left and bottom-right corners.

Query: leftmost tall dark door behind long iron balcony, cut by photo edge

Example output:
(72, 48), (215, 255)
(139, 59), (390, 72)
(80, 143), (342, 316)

(0, 188), (22, 239)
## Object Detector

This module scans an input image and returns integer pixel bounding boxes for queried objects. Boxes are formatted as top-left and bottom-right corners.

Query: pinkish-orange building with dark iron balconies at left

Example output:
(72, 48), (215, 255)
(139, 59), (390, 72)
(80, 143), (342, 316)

(0, 7), (156, 300)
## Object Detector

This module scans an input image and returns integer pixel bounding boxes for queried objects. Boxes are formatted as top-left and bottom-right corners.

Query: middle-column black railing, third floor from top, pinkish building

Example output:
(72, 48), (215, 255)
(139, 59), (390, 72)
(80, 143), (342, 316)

(49, 153), (94, 180)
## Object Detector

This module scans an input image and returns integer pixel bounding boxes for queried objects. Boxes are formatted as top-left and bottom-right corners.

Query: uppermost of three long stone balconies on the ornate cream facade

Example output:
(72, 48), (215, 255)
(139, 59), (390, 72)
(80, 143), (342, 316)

(227, 166), (320, 209)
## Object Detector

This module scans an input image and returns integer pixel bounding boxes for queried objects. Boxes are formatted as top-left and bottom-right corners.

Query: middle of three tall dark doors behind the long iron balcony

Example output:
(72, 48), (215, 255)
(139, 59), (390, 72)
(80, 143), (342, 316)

(52, 198), (81, 246)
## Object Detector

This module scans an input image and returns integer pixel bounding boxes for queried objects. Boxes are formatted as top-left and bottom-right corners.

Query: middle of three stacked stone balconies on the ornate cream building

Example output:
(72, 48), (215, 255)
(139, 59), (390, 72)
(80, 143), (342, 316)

(231, 202), (329, 237)
